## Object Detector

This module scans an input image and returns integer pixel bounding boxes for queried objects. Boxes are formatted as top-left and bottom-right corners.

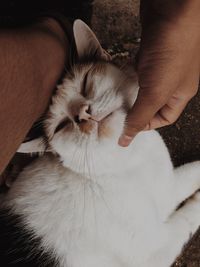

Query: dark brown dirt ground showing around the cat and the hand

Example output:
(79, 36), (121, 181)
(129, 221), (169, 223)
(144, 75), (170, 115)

(92, 0), (200, 267)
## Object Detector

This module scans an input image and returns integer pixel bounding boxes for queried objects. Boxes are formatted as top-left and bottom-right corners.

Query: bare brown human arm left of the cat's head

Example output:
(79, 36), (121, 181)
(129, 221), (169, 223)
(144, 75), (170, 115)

(0, 18), (69, 178)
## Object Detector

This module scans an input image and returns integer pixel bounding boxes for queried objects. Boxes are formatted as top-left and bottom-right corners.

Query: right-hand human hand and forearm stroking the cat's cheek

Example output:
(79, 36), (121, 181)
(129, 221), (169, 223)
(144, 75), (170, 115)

(119, 0), (200, 147)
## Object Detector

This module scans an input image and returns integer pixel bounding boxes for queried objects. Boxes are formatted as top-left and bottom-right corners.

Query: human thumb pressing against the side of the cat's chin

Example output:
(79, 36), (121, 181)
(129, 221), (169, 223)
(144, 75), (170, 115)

(118, 89), (162, 147)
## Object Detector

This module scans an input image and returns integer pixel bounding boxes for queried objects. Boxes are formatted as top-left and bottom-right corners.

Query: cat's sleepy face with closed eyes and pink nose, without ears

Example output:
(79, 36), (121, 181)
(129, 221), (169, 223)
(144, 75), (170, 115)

(45, 18), (137, 172)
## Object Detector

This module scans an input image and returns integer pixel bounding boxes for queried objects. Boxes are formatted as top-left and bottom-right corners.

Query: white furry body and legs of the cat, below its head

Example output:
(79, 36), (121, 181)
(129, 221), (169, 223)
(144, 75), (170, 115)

(2, 131), (200, 267)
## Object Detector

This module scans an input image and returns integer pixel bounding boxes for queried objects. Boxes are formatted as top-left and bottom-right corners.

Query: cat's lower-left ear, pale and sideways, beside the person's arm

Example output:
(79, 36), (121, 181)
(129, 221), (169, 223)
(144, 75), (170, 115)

(17, 137), (47, 153)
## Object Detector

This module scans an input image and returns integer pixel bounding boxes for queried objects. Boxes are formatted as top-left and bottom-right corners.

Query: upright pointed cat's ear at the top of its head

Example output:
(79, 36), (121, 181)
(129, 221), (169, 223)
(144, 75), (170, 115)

(73, 19), (111, 61)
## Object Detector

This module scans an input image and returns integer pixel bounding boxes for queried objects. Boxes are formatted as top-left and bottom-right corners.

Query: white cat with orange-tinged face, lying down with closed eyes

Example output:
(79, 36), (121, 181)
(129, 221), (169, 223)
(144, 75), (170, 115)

(2, 20), (200, 267)
